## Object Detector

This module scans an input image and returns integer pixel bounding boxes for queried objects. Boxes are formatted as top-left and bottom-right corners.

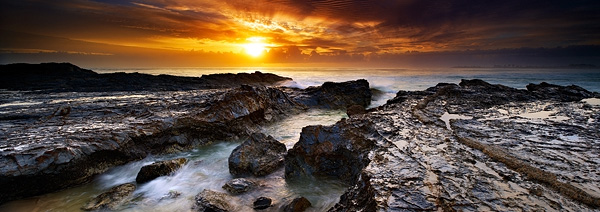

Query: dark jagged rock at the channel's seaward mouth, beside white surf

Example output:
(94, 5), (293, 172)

(294, 79), (372, 109)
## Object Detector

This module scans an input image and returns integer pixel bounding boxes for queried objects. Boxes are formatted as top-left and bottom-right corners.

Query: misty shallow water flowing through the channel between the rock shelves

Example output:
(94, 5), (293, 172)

(0, 110), (347, 212)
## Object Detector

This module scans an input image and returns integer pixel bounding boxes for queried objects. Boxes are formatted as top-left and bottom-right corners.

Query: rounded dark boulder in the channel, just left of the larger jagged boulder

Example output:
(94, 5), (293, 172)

(228, 133), (286, 176)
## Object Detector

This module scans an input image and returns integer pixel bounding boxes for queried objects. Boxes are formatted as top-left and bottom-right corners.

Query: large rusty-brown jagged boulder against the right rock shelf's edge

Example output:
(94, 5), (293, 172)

(285, 119), (374, 183)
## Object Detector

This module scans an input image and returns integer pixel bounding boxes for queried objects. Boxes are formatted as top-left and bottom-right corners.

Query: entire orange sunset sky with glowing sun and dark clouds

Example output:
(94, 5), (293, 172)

(0, 0), (600, 67)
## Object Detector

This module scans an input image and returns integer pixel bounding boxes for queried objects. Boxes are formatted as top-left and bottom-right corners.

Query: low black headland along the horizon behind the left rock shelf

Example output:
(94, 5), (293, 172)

(0, 63), (291, 92)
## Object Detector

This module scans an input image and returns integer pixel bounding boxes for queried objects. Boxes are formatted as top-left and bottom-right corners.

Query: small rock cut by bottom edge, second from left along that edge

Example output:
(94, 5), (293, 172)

(192, 189), (233, 212)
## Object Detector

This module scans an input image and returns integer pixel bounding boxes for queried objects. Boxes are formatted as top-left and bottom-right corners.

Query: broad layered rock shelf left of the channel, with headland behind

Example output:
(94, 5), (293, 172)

(0, 64), (370, 203)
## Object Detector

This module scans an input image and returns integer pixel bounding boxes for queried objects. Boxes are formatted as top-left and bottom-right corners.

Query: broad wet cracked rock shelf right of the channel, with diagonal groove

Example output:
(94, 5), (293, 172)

(324, 80), (600, 211)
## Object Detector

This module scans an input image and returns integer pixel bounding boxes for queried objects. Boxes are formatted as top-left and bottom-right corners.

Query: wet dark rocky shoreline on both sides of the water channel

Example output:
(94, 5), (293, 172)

(0, 64), (600, 211)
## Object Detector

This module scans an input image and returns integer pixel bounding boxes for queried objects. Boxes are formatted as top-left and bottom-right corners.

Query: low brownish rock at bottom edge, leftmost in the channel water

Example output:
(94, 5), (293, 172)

(81, 183), (135, 211)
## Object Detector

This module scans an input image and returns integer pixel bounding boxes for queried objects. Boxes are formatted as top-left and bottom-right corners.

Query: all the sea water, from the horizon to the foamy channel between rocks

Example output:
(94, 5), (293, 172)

(0, 67), (600, 212)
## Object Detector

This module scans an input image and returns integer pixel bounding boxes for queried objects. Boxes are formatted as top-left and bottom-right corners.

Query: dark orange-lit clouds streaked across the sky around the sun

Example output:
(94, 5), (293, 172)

(0, 0), (600, 66)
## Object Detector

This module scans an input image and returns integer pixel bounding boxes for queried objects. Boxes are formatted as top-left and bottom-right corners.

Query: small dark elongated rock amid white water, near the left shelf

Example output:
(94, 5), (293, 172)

(135, 158), (187, 183)
